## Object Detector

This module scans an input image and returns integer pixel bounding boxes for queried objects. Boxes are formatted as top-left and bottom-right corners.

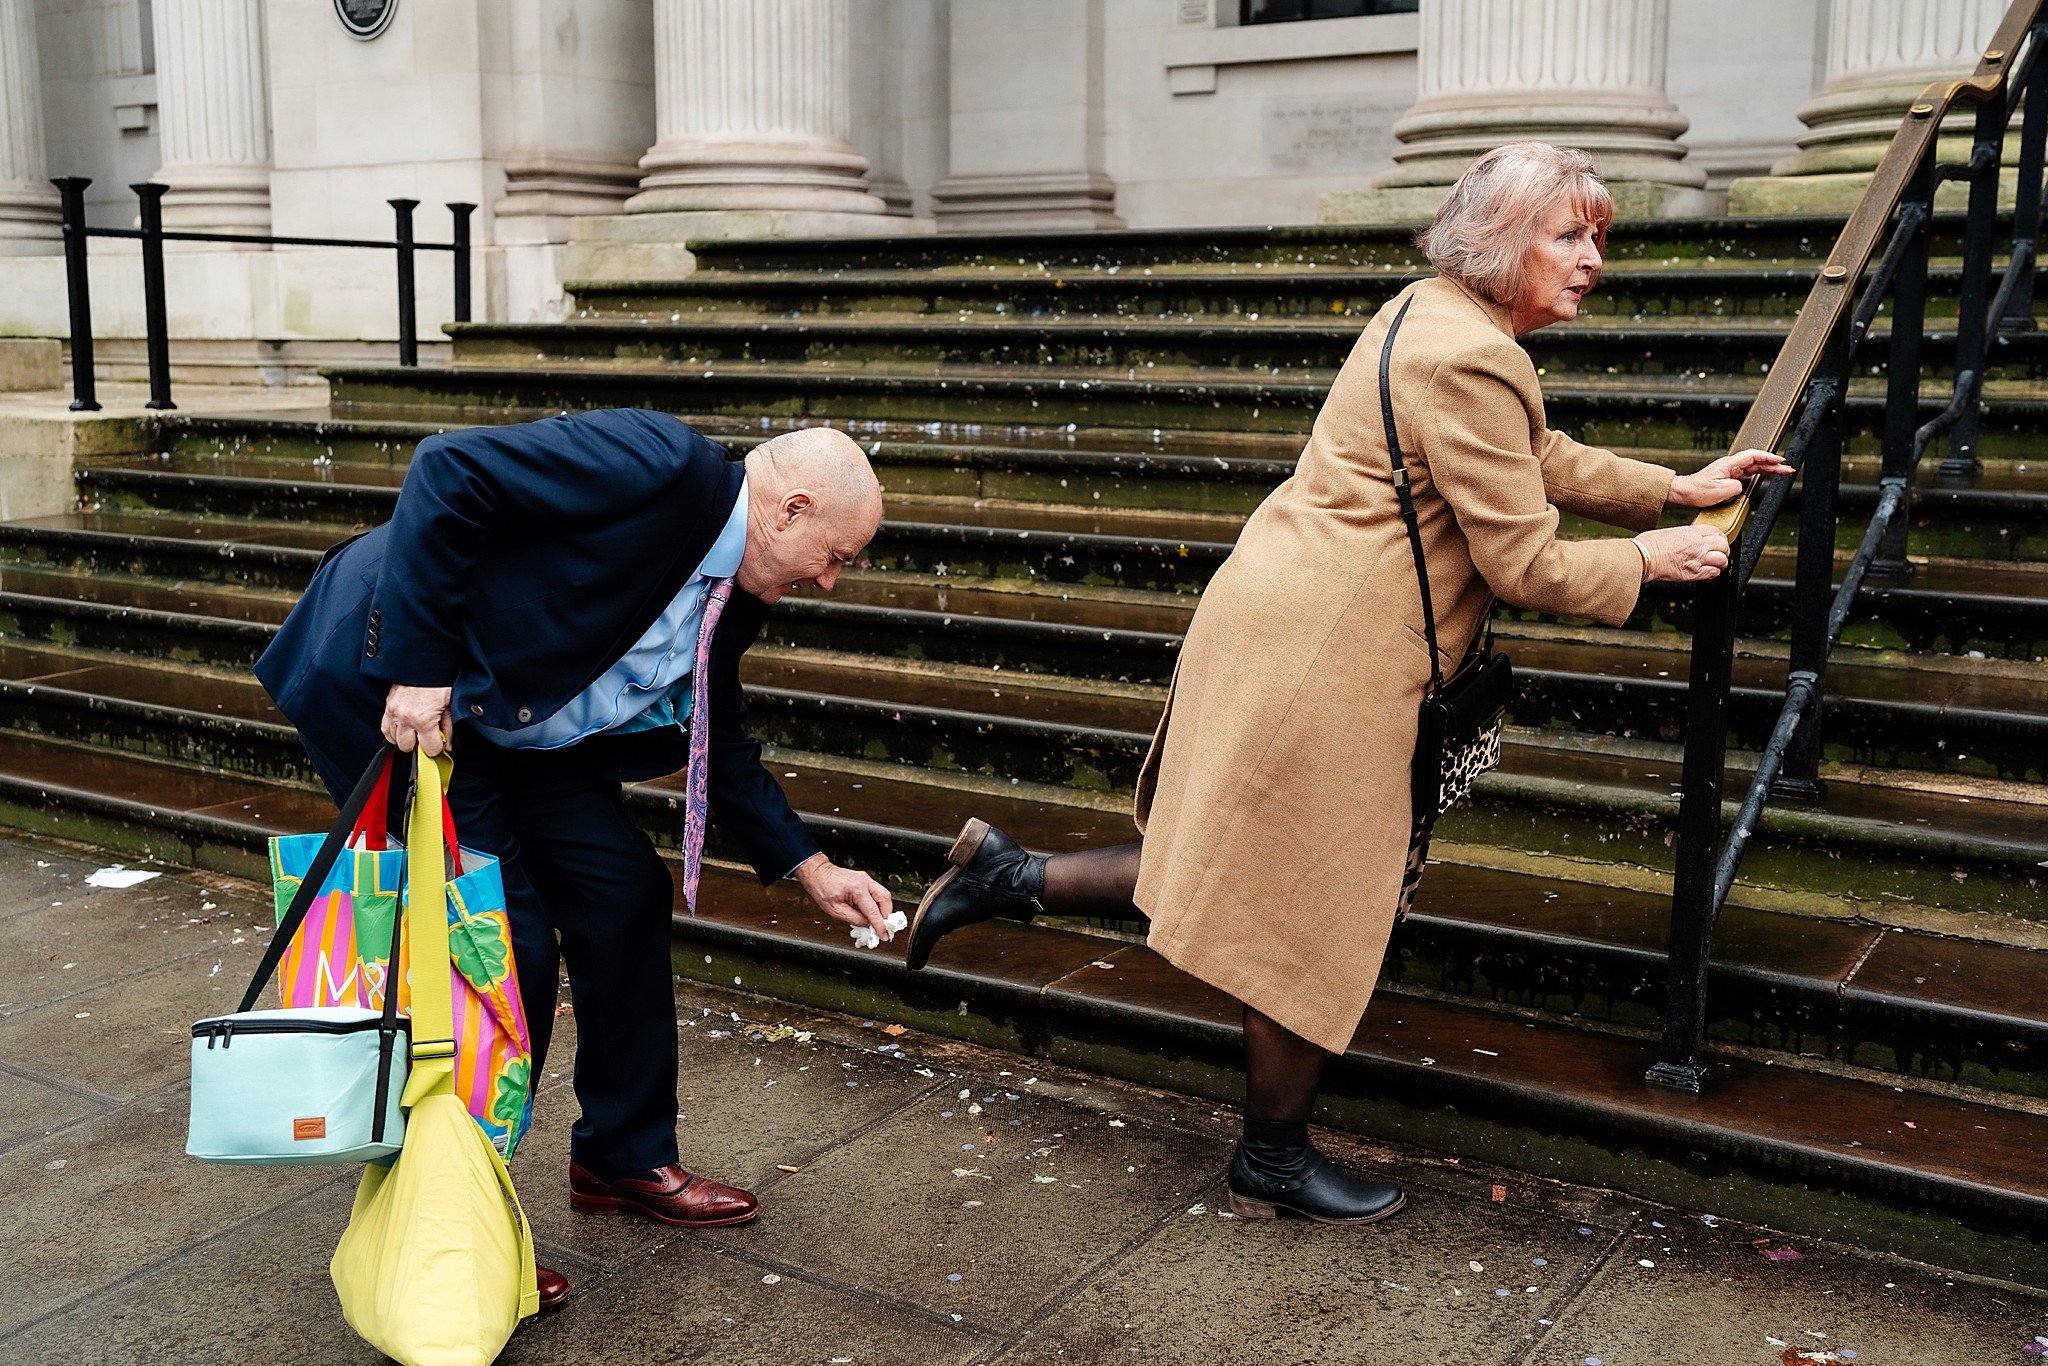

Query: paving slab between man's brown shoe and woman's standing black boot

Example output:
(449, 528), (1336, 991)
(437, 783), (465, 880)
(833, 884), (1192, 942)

(719, 1077), (1229, 1327)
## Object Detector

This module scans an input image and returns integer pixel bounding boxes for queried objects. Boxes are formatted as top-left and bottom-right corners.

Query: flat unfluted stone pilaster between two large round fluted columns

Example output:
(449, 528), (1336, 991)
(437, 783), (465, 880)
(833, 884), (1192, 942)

(932, 0), (1124, 231)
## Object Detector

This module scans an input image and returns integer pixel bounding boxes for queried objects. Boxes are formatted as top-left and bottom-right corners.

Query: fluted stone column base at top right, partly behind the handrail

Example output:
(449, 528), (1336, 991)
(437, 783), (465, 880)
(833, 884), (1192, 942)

(1729, 0), (2017, 213)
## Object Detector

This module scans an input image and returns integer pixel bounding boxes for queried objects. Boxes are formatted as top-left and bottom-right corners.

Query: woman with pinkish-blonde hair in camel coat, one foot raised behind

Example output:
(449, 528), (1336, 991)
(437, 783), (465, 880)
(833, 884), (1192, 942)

(909, 143), (1786, 1223)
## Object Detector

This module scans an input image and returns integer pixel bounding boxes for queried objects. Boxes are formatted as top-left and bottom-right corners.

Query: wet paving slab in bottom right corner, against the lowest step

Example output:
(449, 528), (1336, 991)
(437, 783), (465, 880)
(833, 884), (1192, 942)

(1524, 1210), (2048, 1366)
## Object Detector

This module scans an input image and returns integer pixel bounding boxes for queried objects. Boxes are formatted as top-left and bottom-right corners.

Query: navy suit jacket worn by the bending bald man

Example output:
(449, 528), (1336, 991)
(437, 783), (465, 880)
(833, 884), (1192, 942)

(256, 410), (817, 881)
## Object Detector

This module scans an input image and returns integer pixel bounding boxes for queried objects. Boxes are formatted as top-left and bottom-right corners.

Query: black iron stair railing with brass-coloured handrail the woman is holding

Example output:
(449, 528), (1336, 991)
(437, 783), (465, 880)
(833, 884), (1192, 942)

(1649, 0), (2048, 1092)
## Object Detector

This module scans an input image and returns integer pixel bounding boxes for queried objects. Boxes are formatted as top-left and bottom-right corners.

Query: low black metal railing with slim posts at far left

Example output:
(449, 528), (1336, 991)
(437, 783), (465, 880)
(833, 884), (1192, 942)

(51, 176), (477, 412)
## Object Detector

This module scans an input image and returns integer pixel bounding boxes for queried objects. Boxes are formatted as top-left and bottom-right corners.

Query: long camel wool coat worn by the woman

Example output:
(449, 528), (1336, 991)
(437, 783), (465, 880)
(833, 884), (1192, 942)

(1135, 276), (1673, 1053)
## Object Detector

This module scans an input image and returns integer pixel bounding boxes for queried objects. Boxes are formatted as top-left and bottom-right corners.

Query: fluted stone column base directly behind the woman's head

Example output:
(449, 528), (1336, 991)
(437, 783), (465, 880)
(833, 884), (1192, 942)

(1321, 0), (1718, 223)
